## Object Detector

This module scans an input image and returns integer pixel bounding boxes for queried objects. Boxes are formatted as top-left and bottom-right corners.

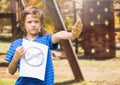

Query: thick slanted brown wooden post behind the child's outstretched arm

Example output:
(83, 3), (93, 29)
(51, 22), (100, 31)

(45, 0), (84, 81)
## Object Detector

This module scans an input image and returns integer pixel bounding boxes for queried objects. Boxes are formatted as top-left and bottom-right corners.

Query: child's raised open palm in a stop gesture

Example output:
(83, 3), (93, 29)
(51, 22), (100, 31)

(72, 18), (83, 38)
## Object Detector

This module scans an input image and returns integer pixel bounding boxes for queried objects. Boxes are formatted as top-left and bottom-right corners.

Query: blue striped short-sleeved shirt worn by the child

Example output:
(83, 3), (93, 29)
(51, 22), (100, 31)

(5, 34), (58, 85)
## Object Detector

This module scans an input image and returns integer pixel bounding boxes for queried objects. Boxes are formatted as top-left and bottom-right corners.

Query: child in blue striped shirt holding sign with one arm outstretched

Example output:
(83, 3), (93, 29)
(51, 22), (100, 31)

(5, 6), (82, 85)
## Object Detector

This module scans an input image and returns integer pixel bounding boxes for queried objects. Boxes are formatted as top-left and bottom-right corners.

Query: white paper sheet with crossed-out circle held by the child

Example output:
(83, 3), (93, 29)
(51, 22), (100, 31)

(20, 39), (48, 81)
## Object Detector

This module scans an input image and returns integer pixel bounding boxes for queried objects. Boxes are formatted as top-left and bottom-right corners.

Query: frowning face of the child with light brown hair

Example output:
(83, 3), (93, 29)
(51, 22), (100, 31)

(24, 14), (41, 36)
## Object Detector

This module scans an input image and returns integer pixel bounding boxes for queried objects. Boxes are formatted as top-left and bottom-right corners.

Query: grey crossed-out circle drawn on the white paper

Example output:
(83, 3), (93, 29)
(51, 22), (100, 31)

(24, 47), (44, 67)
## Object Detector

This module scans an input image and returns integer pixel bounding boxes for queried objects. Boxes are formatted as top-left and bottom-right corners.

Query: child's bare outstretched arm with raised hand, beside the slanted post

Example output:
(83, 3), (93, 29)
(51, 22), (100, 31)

(52, 19), (83, 44)
